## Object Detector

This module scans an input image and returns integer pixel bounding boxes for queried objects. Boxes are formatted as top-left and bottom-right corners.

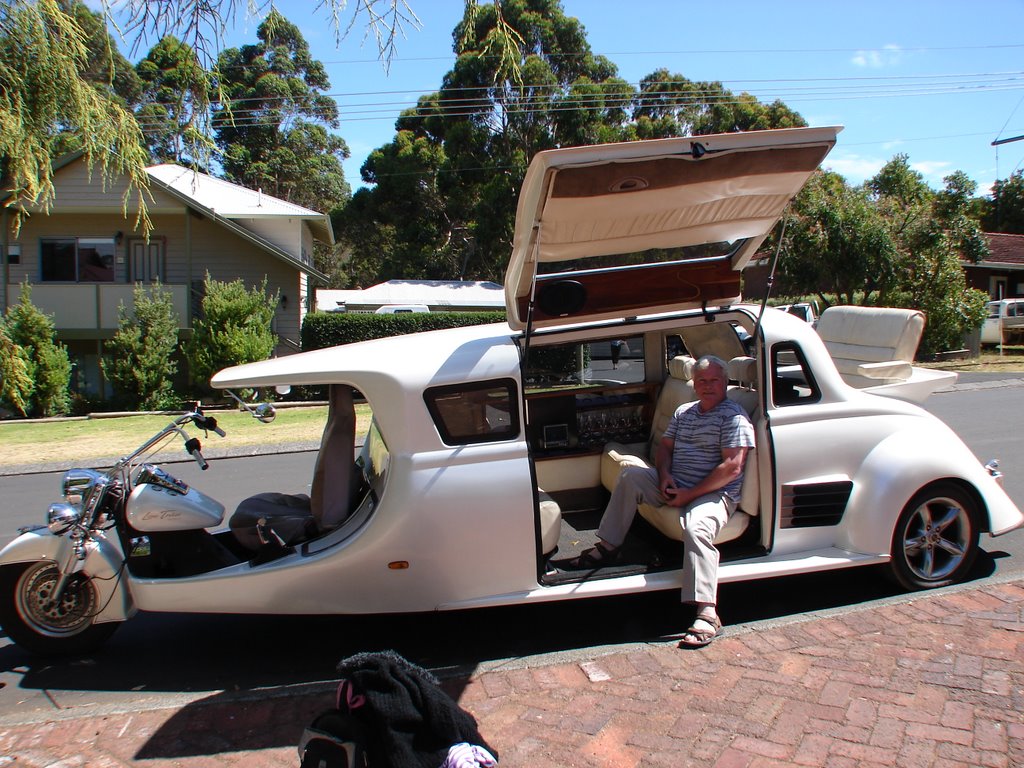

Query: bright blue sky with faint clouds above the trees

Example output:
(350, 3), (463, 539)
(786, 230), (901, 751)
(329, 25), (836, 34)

(163, 0), (1024, 194)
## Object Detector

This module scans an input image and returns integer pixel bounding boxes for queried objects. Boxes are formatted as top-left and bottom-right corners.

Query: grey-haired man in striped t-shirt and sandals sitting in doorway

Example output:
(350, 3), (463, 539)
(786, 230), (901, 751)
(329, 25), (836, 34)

(571, 355), (754, 648)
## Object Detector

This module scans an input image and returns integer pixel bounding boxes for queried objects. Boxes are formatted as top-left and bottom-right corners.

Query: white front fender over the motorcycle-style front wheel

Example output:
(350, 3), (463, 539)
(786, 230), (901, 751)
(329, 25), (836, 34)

(0, 528), (137, 624)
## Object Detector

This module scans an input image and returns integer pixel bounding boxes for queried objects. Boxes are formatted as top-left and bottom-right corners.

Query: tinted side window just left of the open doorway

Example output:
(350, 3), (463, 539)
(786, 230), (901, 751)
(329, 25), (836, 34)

(423, 379), (519, 445)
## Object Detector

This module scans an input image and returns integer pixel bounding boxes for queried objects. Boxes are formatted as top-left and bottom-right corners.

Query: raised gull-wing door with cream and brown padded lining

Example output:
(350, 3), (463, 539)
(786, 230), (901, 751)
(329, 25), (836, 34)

(505, 127), (842, 330)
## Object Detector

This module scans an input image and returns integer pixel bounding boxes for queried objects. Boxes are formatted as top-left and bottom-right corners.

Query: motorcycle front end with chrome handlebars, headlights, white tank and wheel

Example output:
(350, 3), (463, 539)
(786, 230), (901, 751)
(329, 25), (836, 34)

(0, 403), (243, 655)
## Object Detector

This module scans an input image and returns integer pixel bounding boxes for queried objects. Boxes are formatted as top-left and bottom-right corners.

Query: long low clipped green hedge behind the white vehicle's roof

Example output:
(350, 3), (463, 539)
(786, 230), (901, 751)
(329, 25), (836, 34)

(302, 311), (506, 351)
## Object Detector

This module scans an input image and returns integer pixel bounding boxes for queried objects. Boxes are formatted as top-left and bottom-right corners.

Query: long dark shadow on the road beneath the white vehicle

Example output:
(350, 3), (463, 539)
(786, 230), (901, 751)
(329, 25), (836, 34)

(0, 552), (1005, 712)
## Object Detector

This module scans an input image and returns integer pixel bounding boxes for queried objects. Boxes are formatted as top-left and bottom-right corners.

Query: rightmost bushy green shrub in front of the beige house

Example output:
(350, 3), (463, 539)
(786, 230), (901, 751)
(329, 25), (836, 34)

(185, 272), (278, 384)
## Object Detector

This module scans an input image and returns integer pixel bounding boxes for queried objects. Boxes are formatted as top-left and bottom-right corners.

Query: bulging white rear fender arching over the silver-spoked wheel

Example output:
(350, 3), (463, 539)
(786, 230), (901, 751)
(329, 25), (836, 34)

(838, 422), (1024, 554)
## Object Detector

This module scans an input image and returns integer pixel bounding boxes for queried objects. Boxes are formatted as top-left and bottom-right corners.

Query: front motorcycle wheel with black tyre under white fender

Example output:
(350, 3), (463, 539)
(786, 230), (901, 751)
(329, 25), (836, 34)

(0, 560), (119, 655)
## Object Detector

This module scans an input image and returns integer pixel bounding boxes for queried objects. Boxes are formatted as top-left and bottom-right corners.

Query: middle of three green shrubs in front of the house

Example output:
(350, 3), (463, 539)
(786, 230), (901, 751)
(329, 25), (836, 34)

(102, 283), (178, 411)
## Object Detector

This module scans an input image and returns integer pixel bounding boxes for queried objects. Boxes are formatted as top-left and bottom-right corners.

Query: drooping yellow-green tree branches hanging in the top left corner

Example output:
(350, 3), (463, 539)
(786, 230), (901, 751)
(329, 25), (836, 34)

(0, 0), (423, 236)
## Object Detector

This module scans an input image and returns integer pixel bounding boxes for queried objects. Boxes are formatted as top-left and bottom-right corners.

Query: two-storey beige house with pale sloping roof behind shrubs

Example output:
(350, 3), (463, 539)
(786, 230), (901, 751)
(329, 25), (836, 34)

(0, 156), (334, 394)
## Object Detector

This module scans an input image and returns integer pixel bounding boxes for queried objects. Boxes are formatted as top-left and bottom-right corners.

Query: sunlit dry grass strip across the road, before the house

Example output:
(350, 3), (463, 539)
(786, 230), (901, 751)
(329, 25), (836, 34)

(0, 404), (370, 466)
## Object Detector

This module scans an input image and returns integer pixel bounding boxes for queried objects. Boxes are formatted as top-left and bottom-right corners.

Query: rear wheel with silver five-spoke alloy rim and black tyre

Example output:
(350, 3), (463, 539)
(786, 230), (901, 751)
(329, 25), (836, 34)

(891, 482), (981, 590)
